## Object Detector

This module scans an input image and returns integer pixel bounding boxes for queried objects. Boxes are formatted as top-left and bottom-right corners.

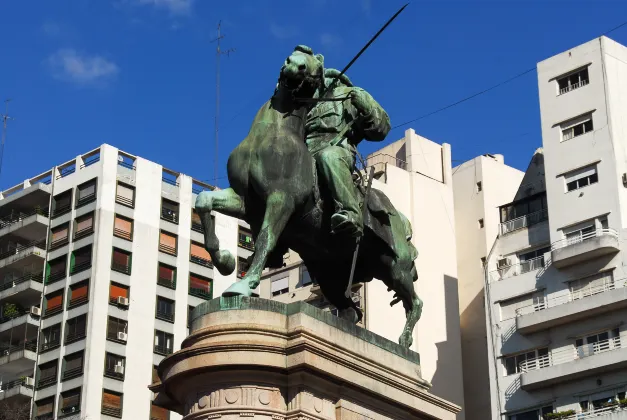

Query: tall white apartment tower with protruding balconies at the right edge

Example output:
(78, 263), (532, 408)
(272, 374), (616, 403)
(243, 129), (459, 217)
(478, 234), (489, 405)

(486, 37), (627, 420)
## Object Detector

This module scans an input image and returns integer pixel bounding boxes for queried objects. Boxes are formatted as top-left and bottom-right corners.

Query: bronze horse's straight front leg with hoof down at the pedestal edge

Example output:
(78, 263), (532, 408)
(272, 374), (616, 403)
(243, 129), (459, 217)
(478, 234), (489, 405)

(222, 191), (295, 296)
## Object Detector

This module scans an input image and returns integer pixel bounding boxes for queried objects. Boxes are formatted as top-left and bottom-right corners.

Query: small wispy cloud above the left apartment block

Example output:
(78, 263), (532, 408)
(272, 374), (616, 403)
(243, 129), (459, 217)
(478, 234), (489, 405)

(48, 48), (120, 86)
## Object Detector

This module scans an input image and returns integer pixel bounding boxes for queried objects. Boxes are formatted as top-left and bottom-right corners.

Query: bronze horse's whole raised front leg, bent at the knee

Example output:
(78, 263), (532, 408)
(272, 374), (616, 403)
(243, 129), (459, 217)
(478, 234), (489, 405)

(196, 188), (245, 276)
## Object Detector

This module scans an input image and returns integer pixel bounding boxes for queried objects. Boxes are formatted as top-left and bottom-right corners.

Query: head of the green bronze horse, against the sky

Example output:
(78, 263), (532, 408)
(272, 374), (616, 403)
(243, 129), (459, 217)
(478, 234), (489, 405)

(279, 45), (324, 97)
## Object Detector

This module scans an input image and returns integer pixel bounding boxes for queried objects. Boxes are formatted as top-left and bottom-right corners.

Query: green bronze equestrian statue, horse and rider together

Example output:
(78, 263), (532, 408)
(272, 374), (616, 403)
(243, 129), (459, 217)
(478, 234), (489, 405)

(196, 45), (422, 347)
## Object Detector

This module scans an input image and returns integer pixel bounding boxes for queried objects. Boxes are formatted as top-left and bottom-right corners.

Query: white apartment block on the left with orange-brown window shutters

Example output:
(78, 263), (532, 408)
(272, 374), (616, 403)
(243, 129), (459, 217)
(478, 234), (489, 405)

(0, 145), (251, 420)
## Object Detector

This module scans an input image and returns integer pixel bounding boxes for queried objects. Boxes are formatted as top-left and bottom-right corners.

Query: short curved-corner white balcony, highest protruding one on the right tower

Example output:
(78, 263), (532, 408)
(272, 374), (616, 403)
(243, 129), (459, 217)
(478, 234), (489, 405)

(551, 229), (620, 268)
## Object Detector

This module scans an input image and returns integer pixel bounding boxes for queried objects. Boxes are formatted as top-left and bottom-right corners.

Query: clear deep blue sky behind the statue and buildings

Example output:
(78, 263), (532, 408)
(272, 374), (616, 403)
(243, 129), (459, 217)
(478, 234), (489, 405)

(0, 0), (627, 189)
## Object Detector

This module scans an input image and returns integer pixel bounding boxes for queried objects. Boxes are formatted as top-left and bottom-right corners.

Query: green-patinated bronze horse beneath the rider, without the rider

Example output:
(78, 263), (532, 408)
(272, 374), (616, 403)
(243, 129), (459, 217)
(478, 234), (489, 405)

(196, 46), (422, 347)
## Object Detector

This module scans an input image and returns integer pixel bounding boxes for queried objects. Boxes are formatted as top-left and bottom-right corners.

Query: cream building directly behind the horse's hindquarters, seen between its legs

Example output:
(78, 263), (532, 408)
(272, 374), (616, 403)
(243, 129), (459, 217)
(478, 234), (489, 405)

(259, 129), (472, 419)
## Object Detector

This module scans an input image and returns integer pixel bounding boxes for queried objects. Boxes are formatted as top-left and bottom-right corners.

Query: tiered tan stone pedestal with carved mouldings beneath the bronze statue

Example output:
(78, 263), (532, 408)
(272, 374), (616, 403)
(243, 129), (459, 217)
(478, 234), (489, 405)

(151, 297), (460, 420)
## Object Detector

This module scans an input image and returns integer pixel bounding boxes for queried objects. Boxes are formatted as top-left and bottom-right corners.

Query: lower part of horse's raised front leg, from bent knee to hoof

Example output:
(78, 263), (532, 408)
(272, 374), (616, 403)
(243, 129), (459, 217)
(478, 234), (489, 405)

(196, 191), (235, 276)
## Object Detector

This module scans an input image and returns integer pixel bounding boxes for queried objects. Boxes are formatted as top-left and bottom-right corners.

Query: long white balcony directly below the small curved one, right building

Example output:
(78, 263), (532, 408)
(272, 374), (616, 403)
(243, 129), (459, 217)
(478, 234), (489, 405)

(516, 279), (627, 334)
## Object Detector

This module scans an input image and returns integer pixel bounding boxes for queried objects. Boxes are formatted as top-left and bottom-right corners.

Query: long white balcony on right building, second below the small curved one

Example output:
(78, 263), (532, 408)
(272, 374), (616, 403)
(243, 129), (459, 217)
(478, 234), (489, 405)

(520, 337), (627, 391)
